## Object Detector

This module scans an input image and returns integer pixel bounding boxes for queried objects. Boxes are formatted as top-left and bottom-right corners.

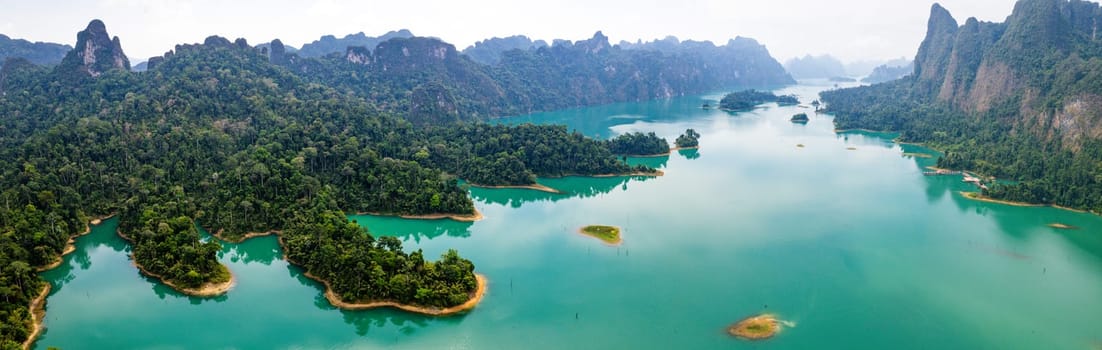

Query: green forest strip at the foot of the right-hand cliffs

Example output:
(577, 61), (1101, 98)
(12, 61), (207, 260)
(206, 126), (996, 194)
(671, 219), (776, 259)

(822, 77), (1102, 211)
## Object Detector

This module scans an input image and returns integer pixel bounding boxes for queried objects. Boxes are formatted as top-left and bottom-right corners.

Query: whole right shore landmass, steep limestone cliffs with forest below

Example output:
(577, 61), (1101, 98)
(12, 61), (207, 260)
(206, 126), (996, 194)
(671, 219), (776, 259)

(822, 0), (1102, 212)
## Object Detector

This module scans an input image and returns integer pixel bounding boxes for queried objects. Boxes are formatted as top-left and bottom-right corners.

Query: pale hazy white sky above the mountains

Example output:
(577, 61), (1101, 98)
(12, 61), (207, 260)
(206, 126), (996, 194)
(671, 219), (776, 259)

(0, 0), (1014, 63)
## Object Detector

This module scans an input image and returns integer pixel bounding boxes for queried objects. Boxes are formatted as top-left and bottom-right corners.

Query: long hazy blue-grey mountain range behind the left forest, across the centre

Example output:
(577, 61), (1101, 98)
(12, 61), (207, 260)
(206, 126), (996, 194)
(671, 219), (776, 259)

(228, 32), (795, 123)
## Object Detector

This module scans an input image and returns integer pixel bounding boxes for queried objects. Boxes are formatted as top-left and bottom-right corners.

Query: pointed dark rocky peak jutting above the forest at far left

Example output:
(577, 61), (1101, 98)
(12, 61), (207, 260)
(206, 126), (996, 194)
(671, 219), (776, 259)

(58, 20), (130, 77)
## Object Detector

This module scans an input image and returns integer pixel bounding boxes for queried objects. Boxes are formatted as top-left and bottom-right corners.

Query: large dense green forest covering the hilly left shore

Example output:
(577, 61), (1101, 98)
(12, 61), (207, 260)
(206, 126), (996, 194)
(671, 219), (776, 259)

(0, 21), (653, 349)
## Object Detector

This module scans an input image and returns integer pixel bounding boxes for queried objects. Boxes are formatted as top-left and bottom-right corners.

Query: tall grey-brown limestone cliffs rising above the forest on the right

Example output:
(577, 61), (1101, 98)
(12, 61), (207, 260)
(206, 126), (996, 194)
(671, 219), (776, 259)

(912, 0), (1102, 150)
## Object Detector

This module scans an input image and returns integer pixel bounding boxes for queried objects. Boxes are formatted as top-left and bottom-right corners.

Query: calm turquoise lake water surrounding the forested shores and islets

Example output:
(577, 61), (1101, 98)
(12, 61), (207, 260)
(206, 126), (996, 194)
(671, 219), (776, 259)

(36, 81), (1102, 349)
